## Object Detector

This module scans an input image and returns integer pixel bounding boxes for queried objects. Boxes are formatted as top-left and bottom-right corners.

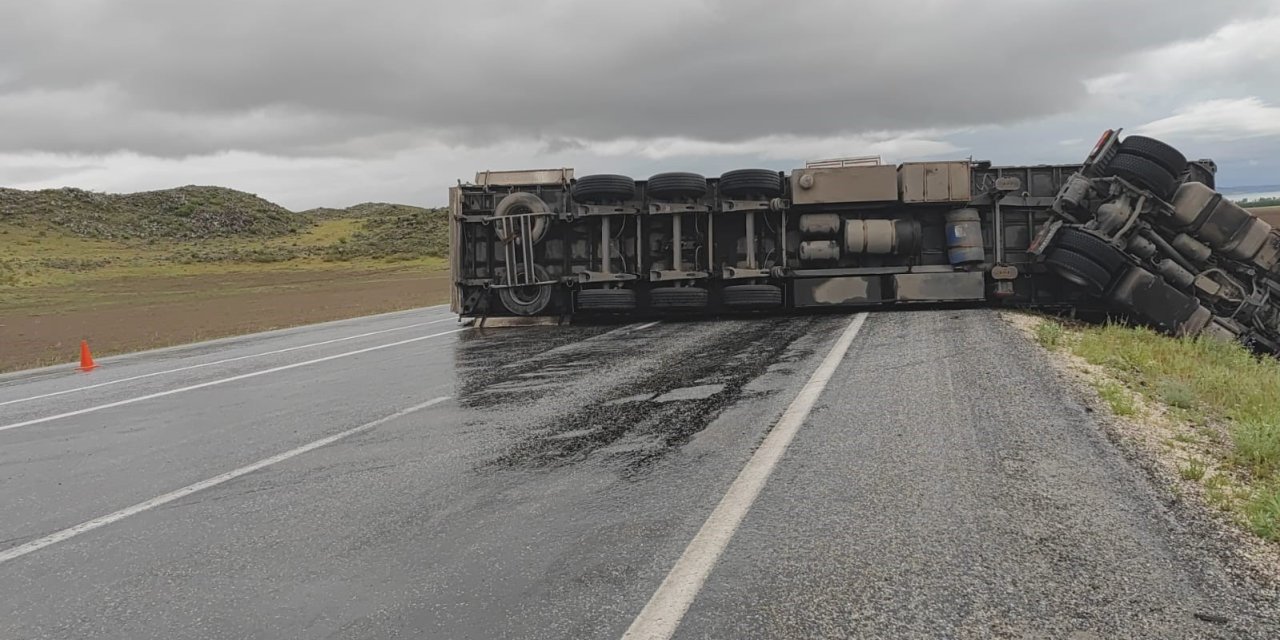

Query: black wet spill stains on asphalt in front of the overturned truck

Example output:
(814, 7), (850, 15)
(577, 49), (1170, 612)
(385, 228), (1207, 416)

(457, 317), (832, 474)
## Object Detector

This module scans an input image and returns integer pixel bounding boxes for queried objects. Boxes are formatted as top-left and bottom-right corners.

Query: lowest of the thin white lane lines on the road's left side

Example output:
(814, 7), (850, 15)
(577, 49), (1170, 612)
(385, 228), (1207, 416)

(0, 396), (449, 564)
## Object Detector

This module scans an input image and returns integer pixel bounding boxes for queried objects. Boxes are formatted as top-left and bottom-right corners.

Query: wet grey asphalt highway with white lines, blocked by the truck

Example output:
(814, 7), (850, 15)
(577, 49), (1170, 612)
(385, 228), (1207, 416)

(0, 308), (1280, 639)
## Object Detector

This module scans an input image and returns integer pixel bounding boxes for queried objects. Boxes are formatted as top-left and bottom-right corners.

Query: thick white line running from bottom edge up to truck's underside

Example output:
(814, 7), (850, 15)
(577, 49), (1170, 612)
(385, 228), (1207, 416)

(622, 314), (867, 640)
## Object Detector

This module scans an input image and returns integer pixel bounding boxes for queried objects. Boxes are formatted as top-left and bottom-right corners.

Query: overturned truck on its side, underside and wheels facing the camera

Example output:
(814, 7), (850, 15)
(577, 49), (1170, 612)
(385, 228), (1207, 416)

(449, 131), (1280, 352)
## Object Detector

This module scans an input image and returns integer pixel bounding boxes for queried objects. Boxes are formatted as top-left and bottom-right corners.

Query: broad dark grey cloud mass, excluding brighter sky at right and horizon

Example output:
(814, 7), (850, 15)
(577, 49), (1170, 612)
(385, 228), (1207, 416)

(0, 0), (1268, 156)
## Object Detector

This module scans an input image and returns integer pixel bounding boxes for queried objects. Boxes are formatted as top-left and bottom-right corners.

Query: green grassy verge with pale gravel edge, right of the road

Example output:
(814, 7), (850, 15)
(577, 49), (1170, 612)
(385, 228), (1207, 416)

(1032, 317), (1280, 543)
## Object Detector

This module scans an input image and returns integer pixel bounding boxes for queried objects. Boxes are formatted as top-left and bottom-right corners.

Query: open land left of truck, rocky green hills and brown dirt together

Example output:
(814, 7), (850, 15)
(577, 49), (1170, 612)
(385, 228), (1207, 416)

(0, 187), (448, 371)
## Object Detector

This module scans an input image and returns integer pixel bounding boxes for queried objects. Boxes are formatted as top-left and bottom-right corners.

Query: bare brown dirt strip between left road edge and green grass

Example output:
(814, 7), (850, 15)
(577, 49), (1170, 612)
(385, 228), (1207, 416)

(0, 268), (449, 371)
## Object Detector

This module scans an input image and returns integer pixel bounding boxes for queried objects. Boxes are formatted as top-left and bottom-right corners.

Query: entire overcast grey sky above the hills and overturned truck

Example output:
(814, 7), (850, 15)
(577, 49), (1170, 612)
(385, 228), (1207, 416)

(0, 0), (1280, 209)
